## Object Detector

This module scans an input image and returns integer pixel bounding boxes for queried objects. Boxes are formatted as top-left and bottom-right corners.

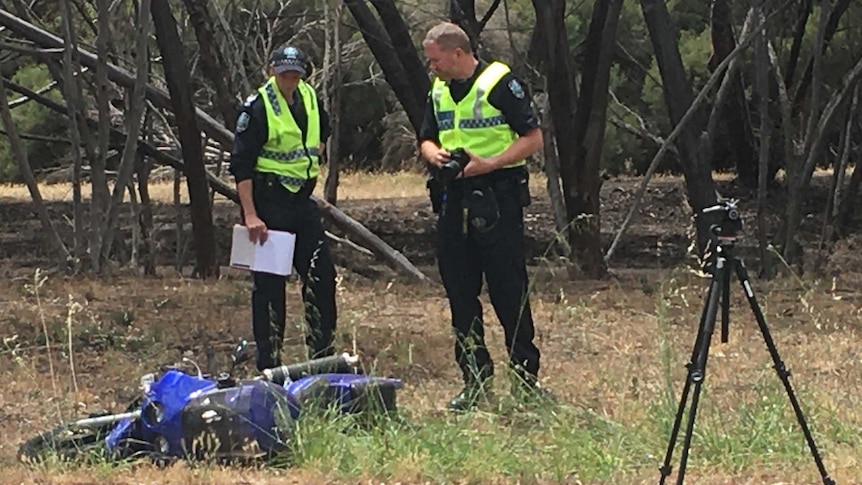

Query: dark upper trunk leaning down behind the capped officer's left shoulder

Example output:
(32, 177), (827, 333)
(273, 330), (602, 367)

(183, 0), (236, 131)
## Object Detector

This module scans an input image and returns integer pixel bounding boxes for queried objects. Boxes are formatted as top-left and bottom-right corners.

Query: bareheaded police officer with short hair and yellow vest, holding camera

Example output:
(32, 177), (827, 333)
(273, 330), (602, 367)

(418, 22), (551, 410)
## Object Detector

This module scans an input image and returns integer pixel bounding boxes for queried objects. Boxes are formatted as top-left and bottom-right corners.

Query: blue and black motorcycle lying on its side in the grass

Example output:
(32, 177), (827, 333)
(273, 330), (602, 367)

(18, 341), (402, 462)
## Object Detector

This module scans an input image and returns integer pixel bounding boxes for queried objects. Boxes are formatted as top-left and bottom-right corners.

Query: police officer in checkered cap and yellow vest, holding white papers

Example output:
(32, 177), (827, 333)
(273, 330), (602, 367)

(230, 45), (336, 370)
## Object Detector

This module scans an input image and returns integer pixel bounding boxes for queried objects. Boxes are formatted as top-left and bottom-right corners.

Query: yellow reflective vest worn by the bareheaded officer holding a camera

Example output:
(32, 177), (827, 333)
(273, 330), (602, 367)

(431, 62), (526, 168)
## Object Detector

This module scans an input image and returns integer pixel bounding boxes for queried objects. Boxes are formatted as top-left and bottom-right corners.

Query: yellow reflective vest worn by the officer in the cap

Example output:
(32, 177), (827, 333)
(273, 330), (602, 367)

(255, 77), (320, 192)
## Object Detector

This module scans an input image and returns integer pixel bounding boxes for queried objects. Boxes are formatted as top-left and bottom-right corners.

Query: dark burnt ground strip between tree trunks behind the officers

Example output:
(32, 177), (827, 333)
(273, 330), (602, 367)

(0, 176), (862, 278)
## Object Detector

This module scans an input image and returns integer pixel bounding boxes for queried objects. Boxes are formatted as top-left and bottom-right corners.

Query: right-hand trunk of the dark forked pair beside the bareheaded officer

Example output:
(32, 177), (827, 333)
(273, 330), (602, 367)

(570, 0), (622, 278)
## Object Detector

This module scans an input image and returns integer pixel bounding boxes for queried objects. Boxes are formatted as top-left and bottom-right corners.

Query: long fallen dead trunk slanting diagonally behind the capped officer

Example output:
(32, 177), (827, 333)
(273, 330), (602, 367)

(0, 5), (428, 281)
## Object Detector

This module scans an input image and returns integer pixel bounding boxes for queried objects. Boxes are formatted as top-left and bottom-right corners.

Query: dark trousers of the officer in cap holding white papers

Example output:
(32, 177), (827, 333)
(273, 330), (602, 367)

(251, 175), (337, 370)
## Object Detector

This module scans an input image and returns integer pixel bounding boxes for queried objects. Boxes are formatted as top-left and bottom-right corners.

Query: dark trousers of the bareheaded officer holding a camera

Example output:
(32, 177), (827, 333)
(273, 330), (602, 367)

(437, 172), (540, 385)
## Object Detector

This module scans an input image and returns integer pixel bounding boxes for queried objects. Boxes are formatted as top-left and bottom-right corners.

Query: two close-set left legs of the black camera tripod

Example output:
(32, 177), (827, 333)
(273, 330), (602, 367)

(659, 263), (725, 485)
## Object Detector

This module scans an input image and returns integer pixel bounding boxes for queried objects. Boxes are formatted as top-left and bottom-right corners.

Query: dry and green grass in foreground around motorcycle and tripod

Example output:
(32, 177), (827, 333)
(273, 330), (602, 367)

(0, 264), (862, 484)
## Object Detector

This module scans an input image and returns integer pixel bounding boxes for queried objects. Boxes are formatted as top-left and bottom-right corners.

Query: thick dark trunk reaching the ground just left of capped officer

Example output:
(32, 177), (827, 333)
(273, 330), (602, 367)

(151, 0), (219, 278)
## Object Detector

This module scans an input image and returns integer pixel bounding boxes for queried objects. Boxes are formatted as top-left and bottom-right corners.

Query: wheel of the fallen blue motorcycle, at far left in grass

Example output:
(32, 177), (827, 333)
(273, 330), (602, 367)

(18, 415), (113, 463)
